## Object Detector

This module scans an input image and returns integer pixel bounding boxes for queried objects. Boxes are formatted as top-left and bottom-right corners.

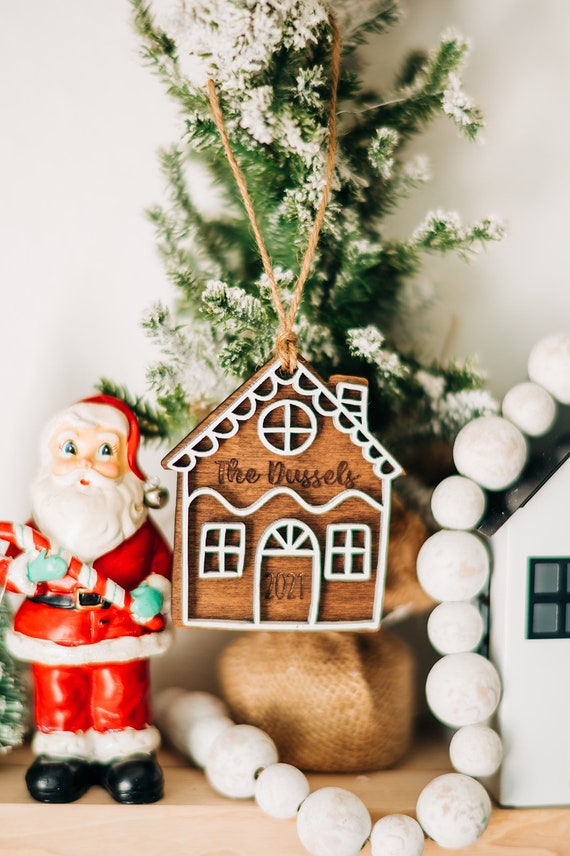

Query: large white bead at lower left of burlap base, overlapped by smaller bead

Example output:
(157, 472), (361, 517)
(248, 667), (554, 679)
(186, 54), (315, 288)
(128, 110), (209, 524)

(205, 725), (279, 799)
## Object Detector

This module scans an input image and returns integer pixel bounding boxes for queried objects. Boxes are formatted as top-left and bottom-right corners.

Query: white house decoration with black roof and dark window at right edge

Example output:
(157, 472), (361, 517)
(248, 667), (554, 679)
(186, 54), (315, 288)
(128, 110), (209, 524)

(479, 407), (570, 807)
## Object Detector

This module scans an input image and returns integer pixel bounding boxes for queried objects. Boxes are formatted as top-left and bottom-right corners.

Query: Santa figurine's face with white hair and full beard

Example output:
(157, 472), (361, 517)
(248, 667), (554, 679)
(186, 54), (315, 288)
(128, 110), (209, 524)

(32, 420), (147, 563)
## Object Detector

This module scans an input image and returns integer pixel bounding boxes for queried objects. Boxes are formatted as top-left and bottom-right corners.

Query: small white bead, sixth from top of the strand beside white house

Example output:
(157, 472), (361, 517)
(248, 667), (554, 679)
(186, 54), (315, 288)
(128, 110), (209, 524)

(427, 600), (485, 654)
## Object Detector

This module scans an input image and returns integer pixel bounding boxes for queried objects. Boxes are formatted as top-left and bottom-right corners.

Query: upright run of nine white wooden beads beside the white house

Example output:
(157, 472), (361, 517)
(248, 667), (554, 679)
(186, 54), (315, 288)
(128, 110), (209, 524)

(416, 333), (570, 847)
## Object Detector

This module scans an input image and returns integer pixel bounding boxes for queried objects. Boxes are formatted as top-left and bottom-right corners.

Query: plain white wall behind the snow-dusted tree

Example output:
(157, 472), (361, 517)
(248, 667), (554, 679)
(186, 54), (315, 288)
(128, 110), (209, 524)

(0, 0), (570, 686)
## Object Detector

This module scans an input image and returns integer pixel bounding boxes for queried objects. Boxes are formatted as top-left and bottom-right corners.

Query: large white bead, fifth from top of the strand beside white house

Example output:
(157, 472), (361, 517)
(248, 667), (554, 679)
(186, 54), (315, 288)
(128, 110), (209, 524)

(416, 529), (489, 601)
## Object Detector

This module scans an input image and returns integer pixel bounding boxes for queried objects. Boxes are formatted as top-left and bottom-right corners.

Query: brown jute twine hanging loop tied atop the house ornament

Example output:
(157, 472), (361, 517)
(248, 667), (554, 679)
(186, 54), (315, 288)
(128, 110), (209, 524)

(208, 13), (341, 375)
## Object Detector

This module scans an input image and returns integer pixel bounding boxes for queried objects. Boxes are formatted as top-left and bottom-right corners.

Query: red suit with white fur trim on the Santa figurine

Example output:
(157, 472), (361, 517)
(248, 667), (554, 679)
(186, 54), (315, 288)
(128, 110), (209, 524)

(6, 518), (172, 744)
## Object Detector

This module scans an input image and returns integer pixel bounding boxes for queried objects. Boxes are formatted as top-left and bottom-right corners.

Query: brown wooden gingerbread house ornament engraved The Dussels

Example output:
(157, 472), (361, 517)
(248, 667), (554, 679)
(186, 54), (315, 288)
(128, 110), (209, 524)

(162, 358), (401, 630)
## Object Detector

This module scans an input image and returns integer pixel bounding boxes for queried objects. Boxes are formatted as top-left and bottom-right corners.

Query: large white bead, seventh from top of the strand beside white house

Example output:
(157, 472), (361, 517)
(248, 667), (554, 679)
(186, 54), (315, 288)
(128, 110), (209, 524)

(426, 653), (501, 728)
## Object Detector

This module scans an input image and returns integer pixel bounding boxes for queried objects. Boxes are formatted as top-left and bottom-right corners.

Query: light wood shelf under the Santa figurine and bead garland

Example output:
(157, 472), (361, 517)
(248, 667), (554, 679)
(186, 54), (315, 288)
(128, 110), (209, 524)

(0, 737), (570, 856)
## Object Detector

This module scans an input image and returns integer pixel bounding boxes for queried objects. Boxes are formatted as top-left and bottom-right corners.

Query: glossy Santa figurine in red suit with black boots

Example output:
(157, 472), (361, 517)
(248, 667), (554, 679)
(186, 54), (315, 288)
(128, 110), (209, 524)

(7, 395), (171, 804)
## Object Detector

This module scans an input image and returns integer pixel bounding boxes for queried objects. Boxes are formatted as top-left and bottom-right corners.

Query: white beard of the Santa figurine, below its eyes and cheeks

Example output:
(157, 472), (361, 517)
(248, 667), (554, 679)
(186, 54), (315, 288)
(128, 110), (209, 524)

(32, 470), (147, 564)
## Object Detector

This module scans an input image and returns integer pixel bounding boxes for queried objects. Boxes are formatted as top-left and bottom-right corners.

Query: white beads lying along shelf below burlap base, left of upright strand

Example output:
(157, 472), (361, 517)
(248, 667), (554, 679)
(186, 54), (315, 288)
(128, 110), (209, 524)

(155, 689), (424, 856)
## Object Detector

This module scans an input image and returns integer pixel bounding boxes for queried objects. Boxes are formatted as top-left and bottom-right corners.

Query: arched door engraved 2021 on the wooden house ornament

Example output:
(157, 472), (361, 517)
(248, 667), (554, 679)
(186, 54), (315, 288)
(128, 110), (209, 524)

(253, 518), (321, 624)
